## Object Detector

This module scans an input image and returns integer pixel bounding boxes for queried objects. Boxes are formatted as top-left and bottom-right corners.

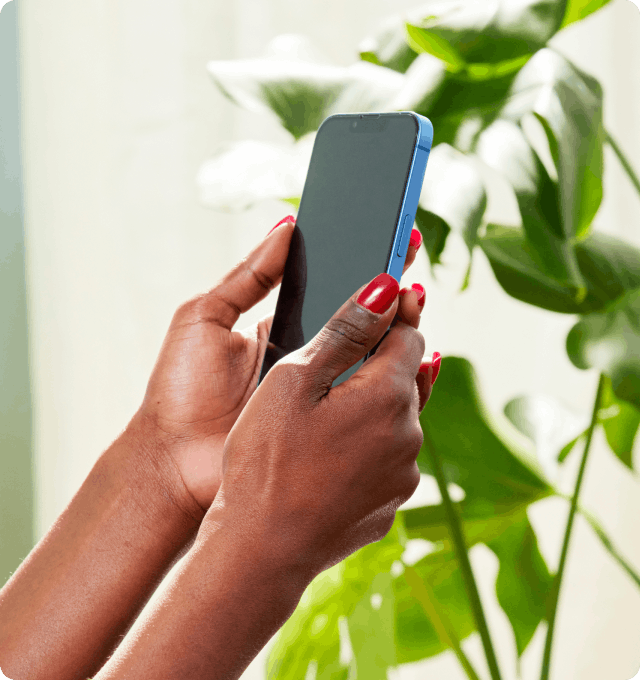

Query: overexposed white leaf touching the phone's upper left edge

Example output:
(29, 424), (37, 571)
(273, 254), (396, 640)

(197, 135), (315, 212)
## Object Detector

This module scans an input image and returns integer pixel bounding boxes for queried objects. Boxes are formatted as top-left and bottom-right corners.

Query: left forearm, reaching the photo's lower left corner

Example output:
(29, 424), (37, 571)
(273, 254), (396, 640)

(0, 414), (204, 680)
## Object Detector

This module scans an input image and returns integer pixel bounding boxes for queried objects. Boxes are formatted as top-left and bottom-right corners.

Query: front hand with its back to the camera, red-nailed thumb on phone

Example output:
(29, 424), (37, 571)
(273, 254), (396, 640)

(202, 274), (440, 578)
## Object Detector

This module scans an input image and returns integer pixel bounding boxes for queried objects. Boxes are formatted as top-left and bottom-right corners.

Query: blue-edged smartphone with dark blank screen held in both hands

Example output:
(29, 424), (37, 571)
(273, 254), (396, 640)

(258, 111), (433, 387)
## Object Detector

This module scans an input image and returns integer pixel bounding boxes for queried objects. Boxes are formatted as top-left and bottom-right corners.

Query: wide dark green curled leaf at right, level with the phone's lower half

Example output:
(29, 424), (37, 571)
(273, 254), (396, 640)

(479, 225), (640, 314)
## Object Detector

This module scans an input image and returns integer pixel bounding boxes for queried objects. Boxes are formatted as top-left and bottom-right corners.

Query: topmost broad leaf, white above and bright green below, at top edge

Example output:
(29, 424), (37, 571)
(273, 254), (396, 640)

(407, 0), (566, 71)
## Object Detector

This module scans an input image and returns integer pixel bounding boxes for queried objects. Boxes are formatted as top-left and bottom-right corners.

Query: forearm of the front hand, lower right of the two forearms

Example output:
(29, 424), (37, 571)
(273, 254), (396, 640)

(94, 502), (311, 680)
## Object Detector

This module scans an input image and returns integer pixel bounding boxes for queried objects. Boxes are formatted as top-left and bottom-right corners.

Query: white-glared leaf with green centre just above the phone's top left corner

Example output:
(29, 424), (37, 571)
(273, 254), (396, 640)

(207, 36), (405, 139)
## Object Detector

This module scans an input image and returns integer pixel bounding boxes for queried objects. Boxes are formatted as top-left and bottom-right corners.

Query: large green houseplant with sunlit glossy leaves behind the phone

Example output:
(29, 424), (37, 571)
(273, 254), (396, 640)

(199, 0), (640, 680)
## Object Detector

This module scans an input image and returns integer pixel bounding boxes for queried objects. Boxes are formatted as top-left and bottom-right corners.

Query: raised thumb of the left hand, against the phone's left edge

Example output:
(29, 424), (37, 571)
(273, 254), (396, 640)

(192, 215), (295, 329)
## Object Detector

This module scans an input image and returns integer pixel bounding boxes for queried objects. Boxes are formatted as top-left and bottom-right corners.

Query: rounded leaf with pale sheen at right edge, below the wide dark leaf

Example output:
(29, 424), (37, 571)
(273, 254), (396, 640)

(567, 289), (640, 410)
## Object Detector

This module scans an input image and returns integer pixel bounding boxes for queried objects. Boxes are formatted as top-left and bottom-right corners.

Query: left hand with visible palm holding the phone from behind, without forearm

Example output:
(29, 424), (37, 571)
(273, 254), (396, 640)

(130, 216), (424, 511)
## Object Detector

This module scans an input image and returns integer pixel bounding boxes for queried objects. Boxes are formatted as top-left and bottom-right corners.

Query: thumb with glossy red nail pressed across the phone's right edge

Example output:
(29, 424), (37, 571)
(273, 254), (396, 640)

(299, 274), (400, 393)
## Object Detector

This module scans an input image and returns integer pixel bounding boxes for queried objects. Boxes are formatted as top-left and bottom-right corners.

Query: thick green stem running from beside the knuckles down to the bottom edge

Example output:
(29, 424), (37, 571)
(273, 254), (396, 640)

(424, 428), (501, 680)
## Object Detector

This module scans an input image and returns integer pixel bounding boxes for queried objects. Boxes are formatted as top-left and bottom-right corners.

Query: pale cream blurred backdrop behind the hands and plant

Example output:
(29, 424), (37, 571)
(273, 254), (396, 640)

(0, 0), (640, 680)
